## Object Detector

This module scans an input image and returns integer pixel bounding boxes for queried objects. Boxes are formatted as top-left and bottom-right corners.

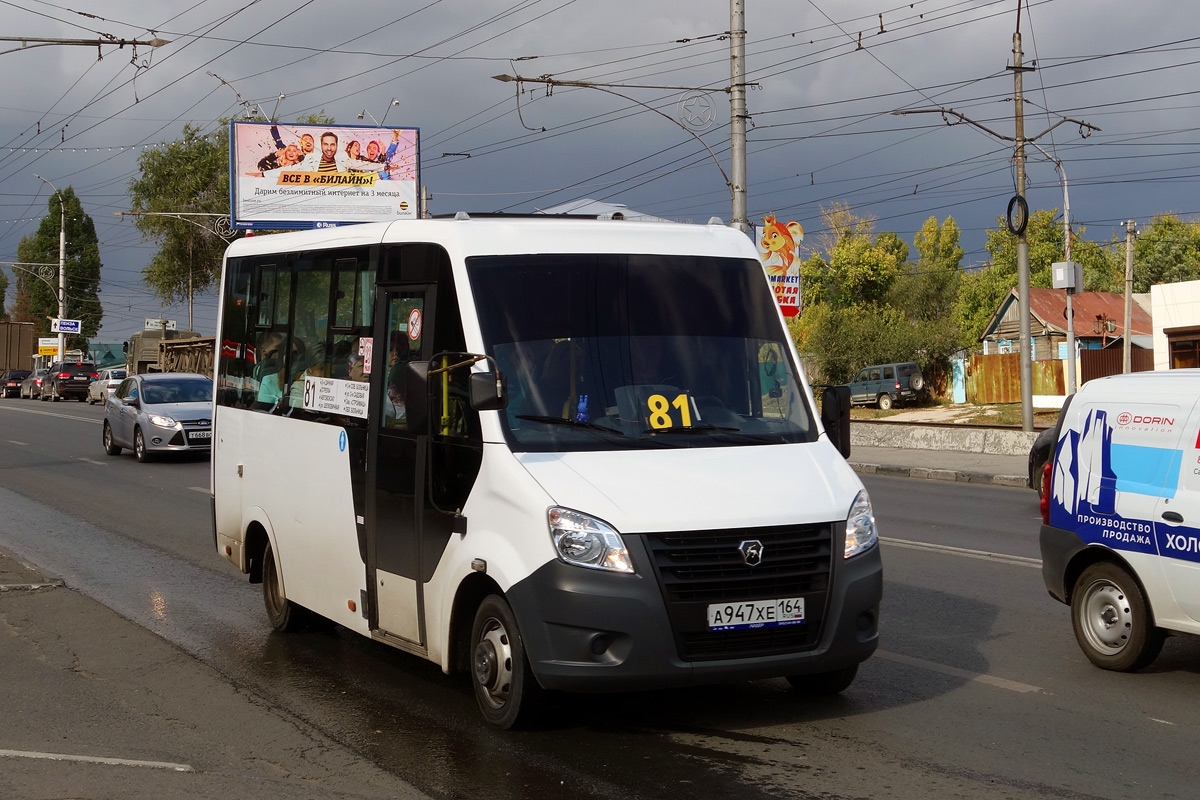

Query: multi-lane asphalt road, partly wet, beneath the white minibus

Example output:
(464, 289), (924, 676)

(0, 401), (1200, 800)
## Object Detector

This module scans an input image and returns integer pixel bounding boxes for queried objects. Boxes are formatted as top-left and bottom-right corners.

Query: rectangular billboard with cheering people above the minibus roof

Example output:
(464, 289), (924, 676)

(229, 122), (420, 229)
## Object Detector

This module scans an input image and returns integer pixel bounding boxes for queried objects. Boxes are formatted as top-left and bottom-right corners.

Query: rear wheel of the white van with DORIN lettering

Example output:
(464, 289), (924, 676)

(1070, 561), (1164, 672)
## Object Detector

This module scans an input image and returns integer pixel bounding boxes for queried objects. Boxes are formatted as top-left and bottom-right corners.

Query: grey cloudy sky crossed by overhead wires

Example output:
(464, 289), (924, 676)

(0, 0), (1200, 341)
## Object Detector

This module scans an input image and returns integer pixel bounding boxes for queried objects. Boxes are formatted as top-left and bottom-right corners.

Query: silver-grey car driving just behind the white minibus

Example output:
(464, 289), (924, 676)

(103, 372), (212, 462)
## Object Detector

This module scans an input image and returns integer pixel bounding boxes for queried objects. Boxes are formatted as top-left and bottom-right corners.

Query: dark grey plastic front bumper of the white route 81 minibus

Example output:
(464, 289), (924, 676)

(508, 536), (883, 692)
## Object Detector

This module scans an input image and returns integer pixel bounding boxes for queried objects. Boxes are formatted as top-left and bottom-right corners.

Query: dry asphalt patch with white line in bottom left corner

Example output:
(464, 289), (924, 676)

(0, 548), (425, 800)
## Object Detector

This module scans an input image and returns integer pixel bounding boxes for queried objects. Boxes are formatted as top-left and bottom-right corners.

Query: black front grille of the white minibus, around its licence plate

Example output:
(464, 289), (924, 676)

(644, 523), (834, 661)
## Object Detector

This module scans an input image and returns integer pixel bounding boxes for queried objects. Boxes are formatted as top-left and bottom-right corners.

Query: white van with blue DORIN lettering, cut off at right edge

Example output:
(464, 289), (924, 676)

(1040, 369), (1200, 670)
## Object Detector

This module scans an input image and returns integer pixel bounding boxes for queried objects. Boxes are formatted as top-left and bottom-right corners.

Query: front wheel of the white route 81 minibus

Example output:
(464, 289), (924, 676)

(469, 595), (544, 729)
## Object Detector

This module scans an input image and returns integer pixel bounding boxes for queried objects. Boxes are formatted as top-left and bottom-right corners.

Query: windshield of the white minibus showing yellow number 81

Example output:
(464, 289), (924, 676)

(467, 254), (816, 452)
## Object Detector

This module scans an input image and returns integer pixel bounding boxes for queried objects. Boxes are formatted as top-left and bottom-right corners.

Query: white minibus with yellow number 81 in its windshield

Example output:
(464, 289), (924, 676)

(212, 212), (882, 728)
